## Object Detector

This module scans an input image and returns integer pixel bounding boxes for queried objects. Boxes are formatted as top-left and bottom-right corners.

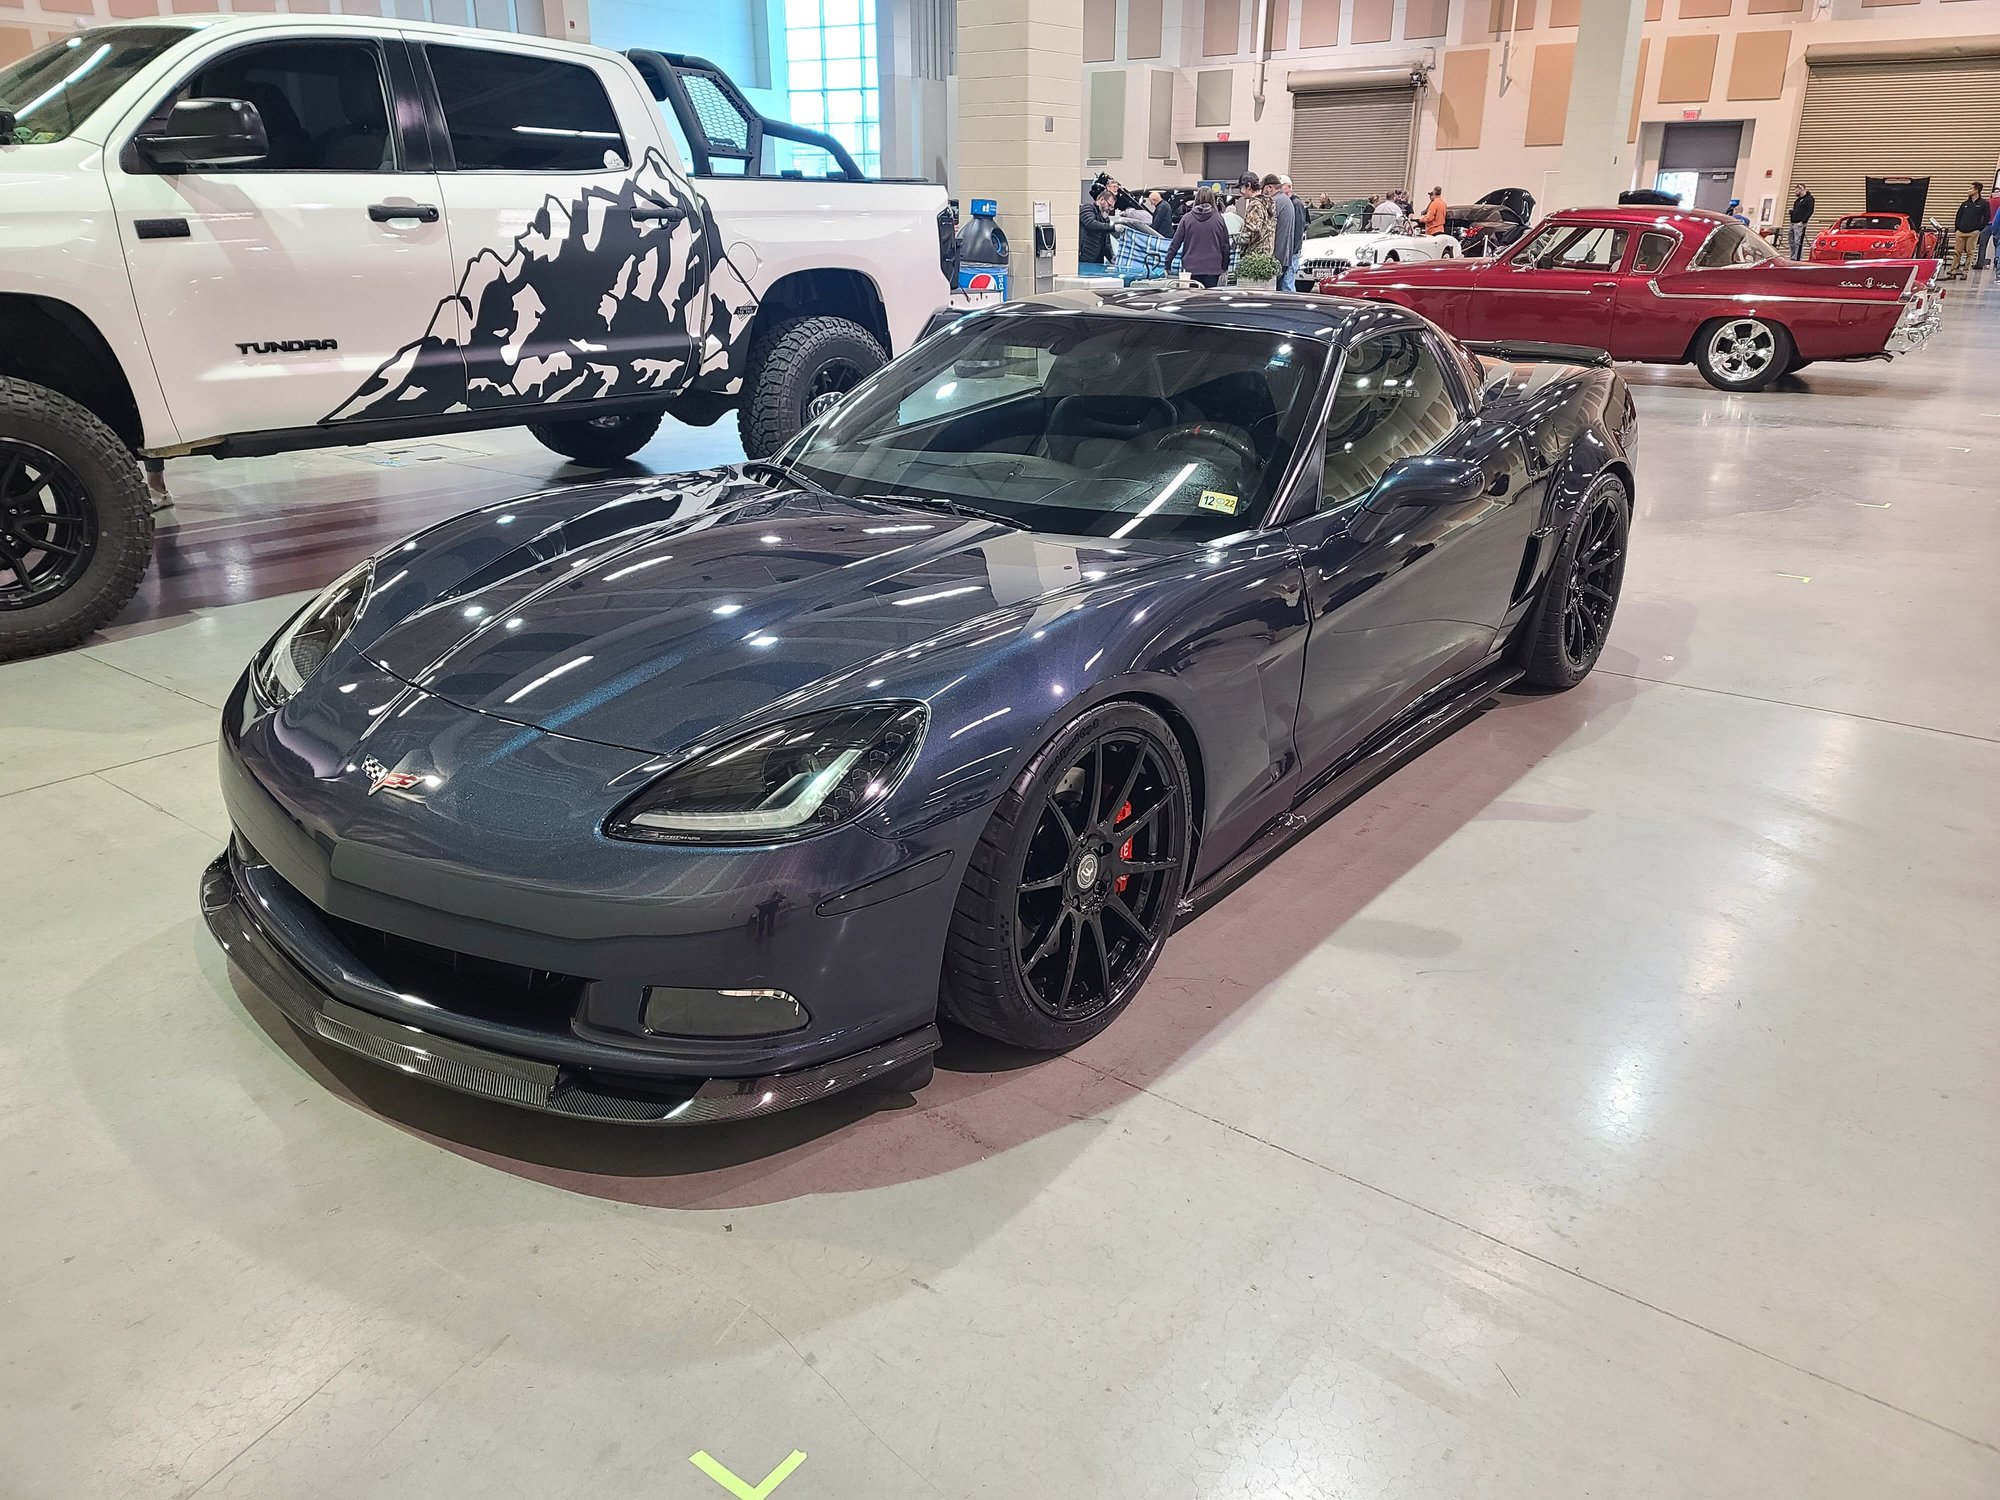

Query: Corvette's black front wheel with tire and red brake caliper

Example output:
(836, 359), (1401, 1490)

(942, 702), (1194, 1052)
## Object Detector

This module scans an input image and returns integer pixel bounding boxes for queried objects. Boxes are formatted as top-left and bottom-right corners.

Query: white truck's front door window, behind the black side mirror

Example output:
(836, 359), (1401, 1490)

(174, 40), (396, 172)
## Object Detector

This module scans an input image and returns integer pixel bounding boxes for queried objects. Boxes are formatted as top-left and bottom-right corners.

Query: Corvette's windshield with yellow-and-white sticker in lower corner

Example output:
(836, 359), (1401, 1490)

(784, 312), (1326, 540)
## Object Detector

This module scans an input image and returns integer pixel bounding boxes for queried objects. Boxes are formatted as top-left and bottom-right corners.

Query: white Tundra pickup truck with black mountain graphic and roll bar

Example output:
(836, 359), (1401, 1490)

(0, 16), (956, 658)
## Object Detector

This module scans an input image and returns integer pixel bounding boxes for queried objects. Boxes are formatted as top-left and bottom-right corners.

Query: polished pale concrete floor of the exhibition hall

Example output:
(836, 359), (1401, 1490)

(0, 284), (2000, 1500)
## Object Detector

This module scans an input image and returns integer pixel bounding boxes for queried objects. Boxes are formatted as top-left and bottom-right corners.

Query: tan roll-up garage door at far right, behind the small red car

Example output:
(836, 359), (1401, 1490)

(1792, 42), (2000, 228)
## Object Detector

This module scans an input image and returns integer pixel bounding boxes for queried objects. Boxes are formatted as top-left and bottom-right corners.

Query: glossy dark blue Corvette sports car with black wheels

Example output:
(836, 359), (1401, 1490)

(202, 292), (1634, 1124)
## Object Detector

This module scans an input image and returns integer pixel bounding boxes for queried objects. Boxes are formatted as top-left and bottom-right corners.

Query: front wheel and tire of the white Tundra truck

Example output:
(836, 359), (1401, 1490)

(0, 378), (152, 660)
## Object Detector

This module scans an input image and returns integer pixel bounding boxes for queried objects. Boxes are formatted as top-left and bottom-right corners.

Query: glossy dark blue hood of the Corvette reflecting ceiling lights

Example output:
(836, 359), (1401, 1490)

(366, 482), (1172, 752)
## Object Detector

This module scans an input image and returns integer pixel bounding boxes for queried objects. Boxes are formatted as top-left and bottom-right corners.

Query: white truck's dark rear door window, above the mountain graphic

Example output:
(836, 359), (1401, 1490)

(424, 46), (632, 172)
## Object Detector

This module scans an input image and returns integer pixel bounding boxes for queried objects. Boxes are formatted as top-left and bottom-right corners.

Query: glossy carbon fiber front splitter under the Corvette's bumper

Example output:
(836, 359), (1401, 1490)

(202, 854), (938, 1126)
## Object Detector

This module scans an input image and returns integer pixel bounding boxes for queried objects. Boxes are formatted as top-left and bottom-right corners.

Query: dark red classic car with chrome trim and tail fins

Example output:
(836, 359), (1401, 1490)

(1318, 208), (1944, 390)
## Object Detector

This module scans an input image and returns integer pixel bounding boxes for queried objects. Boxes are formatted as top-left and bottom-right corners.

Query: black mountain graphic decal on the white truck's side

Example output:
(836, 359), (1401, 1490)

(326, 150), (756, 422)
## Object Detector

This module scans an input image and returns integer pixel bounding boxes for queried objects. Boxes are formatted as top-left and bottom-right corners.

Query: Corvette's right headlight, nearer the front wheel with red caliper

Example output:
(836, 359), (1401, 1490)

(604, 702), (928, 844)
